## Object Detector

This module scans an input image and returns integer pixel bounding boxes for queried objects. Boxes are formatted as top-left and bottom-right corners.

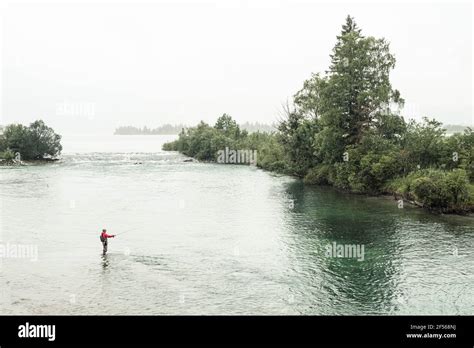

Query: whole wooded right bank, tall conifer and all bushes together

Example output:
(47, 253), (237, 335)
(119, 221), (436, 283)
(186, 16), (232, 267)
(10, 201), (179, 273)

(164, 16), (474, 213)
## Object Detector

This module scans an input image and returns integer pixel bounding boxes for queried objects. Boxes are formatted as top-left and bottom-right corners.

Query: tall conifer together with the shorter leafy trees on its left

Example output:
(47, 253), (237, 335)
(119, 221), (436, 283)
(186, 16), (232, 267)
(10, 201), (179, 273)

(279, 16), (406, 169)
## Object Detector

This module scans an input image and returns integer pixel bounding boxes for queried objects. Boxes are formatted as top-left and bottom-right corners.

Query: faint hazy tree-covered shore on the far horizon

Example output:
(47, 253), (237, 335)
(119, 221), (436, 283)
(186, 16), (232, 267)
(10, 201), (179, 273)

(114, 122), (276, 135)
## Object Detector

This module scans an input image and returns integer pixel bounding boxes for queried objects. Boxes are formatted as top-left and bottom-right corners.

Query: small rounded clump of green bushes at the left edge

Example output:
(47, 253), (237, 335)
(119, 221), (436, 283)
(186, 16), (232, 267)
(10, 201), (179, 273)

(0, 120), (62, 160)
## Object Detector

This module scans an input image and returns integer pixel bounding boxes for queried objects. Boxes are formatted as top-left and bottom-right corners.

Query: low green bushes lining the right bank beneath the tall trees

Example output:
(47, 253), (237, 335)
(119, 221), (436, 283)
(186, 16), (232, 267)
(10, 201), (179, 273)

(163, 116), (474, 215)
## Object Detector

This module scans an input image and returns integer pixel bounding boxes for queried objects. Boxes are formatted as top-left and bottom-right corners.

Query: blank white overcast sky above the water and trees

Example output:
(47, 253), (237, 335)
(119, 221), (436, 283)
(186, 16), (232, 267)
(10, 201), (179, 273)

(0, 0), (473, 133)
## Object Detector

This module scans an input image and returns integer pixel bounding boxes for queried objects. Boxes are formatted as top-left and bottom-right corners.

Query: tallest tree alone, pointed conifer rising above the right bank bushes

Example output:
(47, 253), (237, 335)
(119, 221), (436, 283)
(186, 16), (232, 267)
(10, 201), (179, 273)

(321, 16), (403, 145)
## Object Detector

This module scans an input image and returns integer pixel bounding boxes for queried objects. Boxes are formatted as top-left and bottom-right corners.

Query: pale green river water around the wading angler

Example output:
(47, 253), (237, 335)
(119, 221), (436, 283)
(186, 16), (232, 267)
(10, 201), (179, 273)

(0, 136), (474, 315)
